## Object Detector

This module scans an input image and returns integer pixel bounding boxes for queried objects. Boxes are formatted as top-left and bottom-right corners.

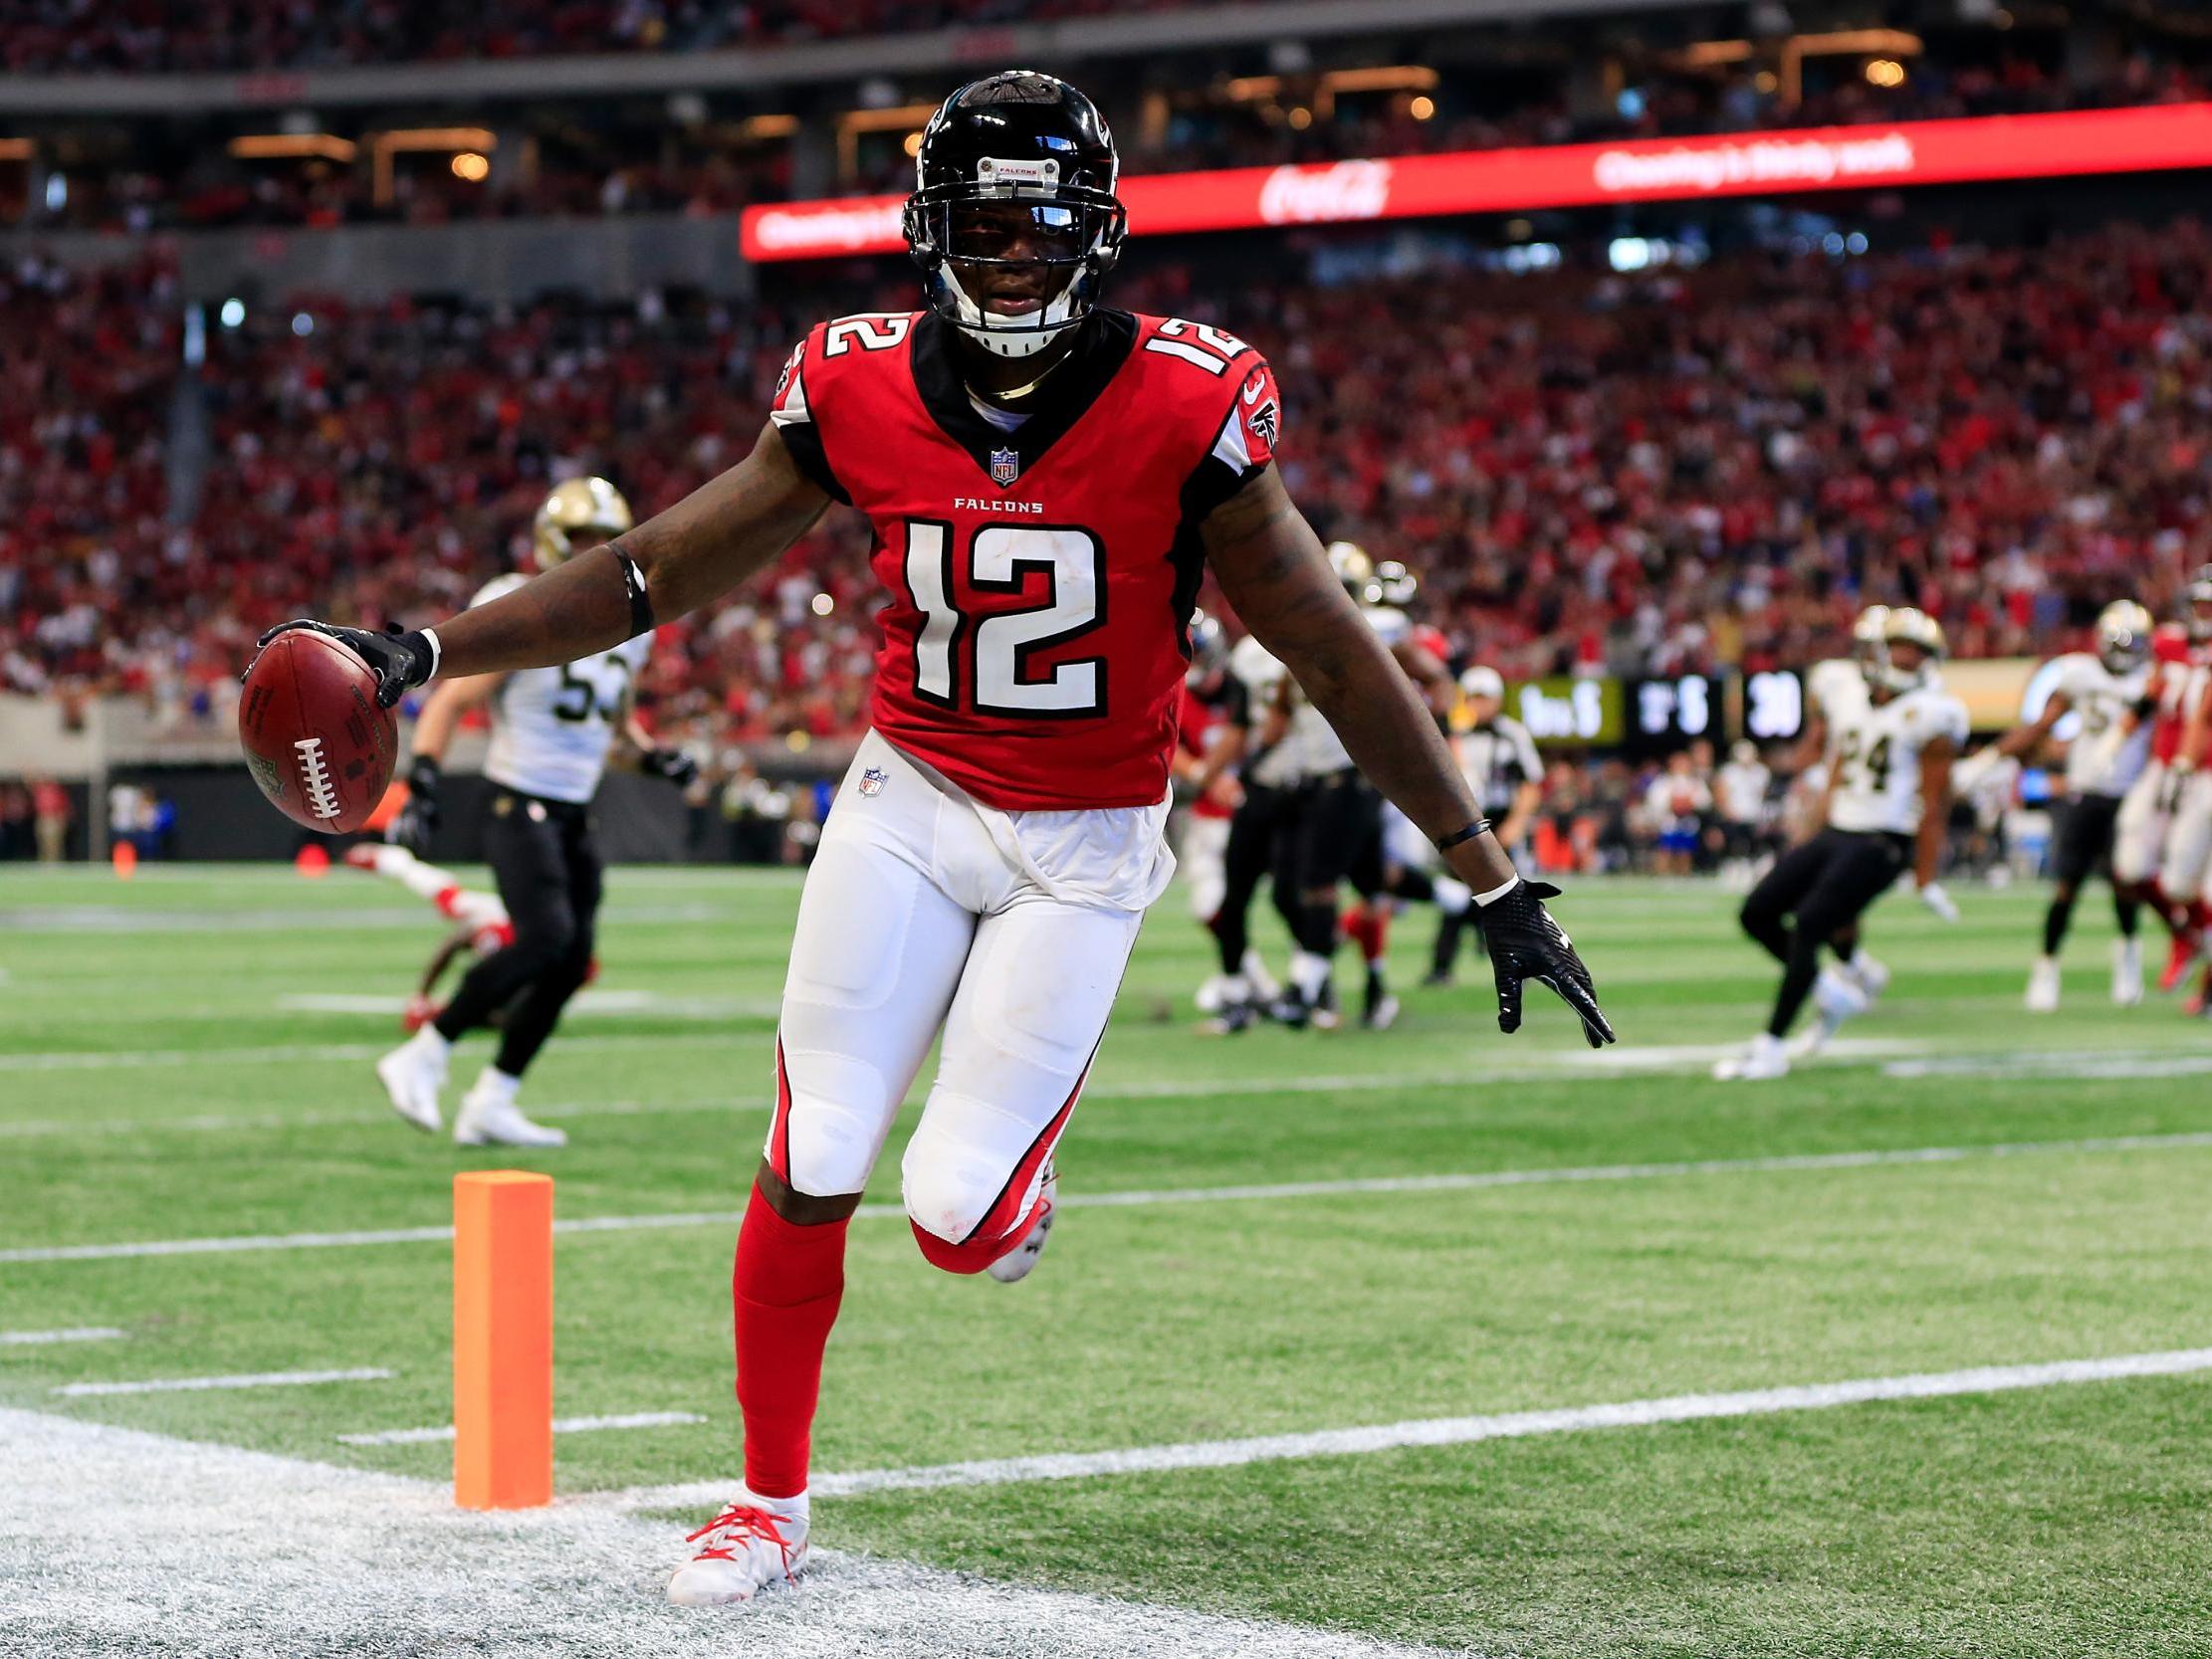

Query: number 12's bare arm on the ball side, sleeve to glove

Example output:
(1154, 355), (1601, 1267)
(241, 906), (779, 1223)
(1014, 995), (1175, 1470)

(422, 425), (829, 690)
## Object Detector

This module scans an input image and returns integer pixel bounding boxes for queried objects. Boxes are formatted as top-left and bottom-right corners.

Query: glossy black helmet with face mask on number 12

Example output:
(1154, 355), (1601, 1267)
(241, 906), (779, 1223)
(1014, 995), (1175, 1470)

(905, 69), (1128, 358)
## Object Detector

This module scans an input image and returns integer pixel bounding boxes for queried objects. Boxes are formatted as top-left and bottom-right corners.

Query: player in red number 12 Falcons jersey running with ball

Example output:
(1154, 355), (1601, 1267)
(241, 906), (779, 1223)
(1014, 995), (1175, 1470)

(258, 71), (1613, 1603)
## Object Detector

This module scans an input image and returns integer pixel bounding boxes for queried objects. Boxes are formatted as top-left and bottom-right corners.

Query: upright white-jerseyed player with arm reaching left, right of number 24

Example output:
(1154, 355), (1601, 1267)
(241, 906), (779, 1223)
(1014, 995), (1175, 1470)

(1957, 599), (2152, 1013)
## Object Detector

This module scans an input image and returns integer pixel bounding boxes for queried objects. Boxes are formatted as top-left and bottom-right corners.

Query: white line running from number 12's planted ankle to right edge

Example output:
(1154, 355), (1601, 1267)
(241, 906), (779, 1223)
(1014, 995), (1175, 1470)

(608, 1348), (2212, 1509)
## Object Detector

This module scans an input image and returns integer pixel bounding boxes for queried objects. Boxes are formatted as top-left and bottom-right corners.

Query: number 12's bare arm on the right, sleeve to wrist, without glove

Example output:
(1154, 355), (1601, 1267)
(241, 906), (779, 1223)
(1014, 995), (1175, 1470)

(1204, 467), (1513, 892)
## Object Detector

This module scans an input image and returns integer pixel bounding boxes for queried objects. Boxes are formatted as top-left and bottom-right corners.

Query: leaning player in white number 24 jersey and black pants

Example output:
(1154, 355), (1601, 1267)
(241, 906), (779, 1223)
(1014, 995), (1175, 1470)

(1714, 608), (1966, 1077)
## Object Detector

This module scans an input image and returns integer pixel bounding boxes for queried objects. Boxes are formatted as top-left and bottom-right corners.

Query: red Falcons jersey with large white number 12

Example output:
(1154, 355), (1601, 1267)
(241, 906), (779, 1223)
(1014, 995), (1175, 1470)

(770, 311), (1281, 809)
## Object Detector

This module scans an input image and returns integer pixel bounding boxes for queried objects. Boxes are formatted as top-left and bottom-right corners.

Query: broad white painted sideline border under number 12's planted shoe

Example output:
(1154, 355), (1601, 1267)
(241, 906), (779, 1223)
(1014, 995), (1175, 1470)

(0, 1409), (1442, 1659)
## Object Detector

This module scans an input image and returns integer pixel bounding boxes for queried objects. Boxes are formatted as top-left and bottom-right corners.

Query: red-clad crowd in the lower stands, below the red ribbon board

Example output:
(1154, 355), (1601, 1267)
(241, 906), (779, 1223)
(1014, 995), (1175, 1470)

(0, 221), (2212, 751)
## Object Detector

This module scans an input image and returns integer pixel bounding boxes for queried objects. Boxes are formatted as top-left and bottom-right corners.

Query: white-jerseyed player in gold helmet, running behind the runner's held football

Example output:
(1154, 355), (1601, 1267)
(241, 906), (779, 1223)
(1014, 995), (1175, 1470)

(376, 478), (697, 1145)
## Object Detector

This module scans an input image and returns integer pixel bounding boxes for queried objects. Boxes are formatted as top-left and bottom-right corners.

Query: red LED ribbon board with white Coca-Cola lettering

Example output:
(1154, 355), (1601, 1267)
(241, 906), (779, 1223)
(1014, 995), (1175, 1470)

(741, 104), (2212, 261)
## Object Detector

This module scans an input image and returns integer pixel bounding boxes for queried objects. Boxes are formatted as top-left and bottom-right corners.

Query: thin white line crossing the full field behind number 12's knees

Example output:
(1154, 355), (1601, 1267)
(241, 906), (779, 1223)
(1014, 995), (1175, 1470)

(0, 1131), (2212, 1263)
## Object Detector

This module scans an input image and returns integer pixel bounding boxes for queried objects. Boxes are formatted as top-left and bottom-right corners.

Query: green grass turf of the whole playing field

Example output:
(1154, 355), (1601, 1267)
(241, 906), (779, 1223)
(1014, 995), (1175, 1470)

(0, 867), (2212, 1659)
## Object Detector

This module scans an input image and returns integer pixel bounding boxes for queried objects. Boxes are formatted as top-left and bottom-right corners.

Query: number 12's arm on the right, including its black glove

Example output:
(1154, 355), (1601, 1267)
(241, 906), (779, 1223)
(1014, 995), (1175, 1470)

(1202, 467), (1613, 1049)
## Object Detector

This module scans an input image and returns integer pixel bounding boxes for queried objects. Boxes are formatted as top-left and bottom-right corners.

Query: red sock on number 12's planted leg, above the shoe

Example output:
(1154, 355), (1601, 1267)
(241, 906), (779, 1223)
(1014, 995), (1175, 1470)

(730, 1185), (849, 1498)
